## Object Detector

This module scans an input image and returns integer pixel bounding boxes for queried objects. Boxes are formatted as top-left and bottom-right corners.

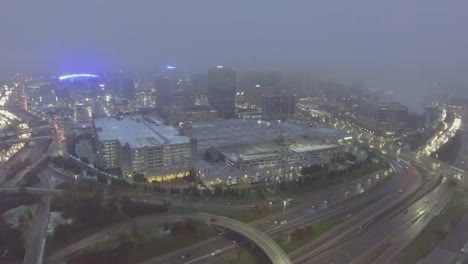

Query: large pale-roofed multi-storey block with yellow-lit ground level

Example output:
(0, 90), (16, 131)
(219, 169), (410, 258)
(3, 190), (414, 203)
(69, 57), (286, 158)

(93, 116), (192, 181)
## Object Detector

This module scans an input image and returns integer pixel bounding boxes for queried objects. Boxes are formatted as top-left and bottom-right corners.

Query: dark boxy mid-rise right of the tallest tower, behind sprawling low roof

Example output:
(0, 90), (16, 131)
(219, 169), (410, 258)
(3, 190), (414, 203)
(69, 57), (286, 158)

(262, 95), (296, 121)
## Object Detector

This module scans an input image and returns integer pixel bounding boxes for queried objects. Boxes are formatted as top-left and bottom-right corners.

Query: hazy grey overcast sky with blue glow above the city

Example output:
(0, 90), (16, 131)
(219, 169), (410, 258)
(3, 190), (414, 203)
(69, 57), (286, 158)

(0, 0), (468, 97)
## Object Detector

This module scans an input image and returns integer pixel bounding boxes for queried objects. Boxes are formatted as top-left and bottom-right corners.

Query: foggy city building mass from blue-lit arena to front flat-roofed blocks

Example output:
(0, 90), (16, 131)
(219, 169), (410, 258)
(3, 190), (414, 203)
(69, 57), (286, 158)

(18, 65), (420, 186)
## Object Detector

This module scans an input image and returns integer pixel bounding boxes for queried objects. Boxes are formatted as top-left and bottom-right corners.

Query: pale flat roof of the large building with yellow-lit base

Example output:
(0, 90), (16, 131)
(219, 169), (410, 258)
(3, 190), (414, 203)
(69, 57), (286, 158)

(94, 116), (190, 148)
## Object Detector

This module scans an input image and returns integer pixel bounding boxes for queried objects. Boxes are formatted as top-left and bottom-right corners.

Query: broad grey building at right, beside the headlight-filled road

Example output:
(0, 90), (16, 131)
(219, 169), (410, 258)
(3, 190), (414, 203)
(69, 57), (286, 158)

(356, 100), (408, 136)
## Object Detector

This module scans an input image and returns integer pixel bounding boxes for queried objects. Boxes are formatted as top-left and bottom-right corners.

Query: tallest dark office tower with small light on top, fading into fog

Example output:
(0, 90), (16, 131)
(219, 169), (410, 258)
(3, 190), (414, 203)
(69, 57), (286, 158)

(208, 66), (236, 118)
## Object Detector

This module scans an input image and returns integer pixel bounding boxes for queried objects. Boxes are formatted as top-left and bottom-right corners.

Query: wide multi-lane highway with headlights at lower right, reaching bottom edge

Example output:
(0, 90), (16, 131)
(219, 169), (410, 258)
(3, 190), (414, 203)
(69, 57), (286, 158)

(304, 178), (454, 263)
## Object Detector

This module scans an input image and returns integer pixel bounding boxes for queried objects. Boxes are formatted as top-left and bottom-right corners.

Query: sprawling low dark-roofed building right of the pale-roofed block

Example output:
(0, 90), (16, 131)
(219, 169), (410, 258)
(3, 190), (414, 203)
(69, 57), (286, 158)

(185, 119), (352, 176)
